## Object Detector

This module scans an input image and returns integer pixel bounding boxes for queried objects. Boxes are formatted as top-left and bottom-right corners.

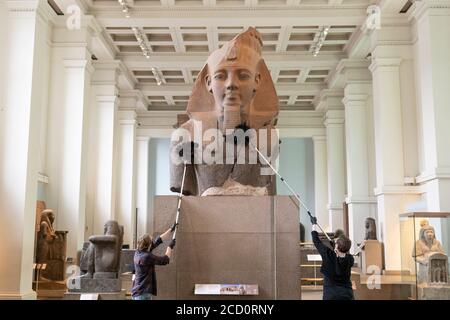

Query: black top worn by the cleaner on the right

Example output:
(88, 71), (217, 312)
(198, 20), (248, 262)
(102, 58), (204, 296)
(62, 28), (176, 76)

(311, 231), (354, 289)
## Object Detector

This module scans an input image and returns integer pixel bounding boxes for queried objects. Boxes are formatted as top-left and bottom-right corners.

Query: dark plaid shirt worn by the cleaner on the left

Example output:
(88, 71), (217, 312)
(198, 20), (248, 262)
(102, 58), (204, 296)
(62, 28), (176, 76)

(131, 236), (170, 297)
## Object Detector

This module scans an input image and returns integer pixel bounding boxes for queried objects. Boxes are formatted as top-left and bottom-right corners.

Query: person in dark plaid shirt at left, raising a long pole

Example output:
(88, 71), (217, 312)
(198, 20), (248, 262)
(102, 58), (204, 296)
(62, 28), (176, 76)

(131, 223), (177, 300)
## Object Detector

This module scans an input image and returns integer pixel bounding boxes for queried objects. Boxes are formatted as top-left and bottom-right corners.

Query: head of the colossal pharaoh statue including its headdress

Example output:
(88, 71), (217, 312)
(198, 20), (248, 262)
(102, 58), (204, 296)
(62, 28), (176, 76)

(187, 28), (278, 133)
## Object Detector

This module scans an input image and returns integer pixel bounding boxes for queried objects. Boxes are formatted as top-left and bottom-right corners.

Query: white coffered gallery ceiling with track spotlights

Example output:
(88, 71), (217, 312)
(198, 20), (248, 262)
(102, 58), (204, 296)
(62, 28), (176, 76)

(54, 0), (384, 110)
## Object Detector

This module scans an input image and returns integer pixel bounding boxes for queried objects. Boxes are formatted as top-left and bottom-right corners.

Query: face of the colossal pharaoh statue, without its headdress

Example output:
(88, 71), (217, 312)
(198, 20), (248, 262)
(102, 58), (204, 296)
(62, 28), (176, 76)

(206, 62), (260, 125)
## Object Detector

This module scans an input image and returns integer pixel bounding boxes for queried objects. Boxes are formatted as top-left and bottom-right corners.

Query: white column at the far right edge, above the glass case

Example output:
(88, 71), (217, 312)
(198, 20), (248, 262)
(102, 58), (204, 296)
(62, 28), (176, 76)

(410, 0), (450, 211)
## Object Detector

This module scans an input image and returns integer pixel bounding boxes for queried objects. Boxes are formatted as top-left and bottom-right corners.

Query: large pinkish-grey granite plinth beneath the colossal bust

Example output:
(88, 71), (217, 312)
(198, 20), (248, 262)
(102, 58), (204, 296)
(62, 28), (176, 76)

(154, 196), (300, 299)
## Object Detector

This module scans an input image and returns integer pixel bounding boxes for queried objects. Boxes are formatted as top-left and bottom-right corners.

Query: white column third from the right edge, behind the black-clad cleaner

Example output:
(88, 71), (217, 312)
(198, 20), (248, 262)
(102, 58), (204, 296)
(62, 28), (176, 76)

(343, 84), (377, 248)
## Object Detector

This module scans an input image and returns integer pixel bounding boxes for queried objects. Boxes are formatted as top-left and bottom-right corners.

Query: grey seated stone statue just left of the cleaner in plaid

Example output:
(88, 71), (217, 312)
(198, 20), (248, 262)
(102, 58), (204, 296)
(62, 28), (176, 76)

(80, 220), (123, 279)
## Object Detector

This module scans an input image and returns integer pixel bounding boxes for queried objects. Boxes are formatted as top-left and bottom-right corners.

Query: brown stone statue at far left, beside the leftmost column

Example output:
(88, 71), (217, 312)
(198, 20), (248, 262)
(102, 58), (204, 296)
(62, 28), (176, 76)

(36, 209), (67, 280)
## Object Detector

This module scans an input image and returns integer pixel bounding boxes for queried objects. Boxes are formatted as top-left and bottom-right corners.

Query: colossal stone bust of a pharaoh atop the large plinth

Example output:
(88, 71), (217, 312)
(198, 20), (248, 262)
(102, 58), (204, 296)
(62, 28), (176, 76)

(170, 28), (279, 196)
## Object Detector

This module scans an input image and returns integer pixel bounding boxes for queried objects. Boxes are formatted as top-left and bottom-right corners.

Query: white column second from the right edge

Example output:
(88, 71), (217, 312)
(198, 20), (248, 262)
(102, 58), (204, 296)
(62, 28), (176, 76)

(370, 57), (418, 271)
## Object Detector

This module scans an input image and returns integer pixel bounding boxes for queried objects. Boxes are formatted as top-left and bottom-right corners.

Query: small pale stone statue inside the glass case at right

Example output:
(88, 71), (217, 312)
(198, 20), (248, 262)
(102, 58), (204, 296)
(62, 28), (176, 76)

(412, 225), (444, 283)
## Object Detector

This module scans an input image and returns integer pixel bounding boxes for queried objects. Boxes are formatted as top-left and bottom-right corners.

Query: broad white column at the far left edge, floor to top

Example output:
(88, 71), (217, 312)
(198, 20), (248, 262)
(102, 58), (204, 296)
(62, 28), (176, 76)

(0, 1), (51, 299)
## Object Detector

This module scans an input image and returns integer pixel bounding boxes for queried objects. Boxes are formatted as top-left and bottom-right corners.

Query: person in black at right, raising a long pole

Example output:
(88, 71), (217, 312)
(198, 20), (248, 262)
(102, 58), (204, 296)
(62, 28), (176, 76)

(310, 216), (355, 300)
